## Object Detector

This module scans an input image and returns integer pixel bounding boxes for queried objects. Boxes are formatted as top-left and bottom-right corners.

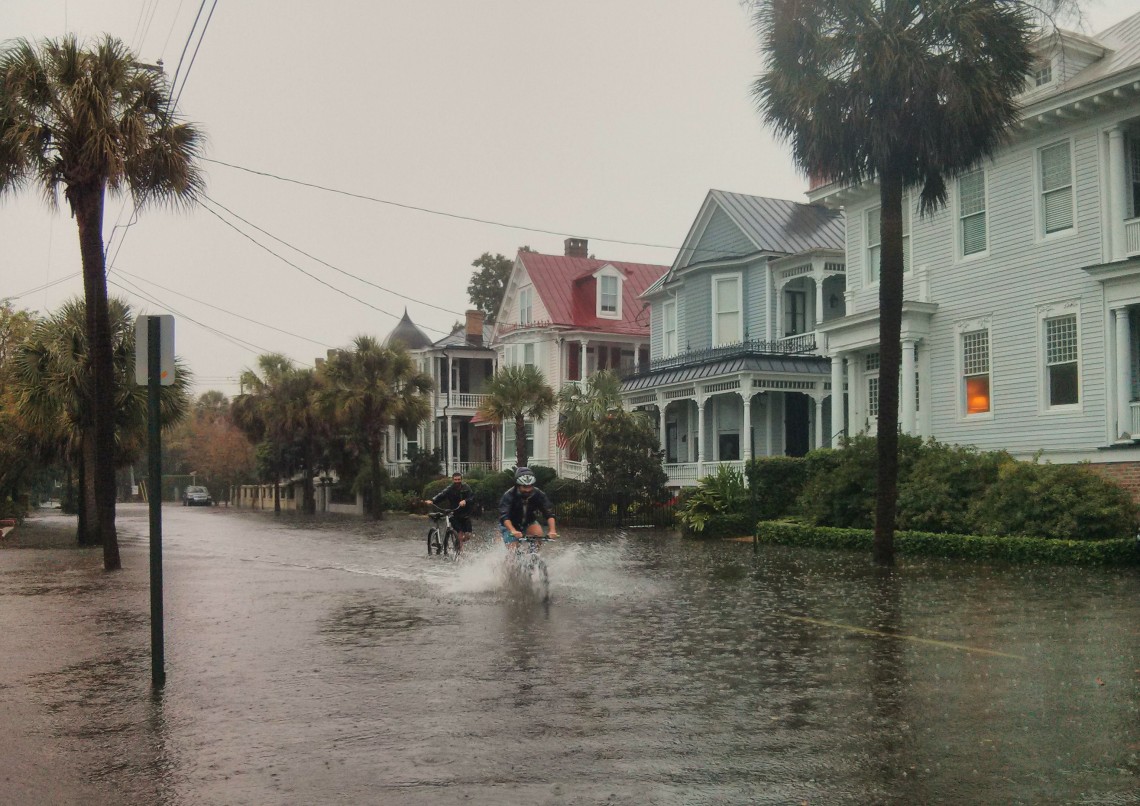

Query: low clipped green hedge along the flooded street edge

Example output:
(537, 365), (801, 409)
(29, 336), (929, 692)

(755, 521), (1140, 565)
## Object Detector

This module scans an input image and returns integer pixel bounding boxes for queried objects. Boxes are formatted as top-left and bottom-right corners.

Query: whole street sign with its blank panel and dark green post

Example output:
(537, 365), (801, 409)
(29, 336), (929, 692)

(135, 316), (174, 689)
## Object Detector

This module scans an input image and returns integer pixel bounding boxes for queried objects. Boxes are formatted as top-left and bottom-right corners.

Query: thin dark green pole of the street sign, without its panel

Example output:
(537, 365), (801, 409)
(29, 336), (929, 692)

(145, 316), (166, 689)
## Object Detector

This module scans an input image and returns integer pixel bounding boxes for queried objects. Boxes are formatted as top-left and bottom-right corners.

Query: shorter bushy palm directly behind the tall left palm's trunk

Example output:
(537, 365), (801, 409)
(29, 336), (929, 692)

(14, 298), (192, 545)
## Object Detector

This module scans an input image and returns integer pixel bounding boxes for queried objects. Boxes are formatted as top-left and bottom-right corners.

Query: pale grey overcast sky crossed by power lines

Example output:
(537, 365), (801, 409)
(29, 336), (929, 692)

(0, 0), (1138, 396)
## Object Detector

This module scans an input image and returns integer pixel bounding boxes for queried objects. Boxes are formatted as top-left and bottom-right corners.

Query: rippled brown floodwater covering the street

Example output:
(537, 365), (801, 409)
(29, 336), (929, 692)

(0, 505), (1140, 806)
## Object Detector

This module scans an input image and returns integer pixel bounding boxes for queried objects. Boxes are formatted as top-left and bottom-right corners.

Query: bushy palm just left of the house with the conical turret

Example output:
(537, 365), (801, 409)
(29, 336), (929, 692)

(320, 335), (433, 518)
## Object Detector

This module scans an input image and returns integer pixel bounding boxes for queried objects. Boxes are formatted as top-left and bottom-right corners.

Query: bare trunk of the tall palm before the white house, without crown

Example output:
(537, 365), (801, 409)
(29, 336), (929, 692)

(871, 171), (903, 565)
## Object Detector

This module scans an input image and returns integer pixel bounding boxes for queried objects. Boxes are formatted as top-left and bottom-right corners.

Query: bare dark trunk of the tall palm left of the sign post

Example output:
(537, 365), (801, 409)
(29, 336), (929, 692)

(67, 180), (122, 571)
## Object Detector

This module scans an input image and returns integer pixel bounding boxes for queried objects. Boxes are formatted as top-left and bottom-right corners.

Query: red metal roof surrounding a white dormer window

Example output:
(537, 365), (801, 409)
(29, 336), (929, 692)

(519, 252), (669, 336)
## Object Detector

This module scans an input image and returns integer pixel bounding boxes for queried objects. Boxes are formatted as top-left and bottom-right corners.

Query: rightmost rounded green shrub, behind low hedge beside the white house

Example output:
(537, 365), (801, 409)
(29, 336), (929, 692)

(970, 458), (1137, 540)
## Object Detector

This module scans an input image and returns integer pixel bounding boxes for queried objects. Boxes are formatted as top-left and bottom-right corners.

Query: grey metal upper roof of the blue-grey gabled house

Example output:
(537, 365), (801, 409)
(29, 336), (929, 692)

(709, 190), (844, 254)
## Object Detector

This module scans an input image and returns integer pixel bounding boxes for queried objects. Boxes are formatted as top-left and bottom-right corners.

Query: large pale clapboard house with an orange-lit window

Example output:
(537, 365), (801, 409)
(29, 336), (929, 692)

(808, 14), (1140, 497)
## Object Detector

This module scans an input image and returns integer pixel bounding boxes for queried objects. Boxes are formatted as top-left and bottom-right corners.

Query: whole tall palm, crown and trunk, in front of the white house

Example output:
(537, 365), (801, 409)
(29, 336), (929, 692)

(754, 0), (1033, 565)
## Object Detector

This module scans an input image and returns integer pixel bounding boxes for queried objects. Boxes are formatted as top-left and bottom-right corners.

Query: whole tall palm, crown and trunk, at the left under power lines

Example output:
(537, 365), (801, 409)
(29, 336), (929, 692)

(0, 35), (202, 570)
